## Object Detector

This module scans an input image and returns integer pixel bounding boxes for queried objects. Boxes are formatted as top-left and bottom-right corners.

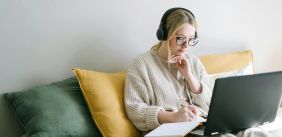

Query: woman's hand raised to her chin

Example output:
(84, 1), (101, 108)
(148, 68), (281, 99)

(172, 55), (190, 77)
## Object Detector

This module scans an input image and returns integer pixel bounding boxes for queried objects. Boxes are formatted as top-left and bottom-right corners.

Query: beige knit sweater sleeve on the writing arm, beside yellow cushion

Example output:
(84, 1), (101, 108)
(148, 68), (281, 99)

(124, 54), (164, 131)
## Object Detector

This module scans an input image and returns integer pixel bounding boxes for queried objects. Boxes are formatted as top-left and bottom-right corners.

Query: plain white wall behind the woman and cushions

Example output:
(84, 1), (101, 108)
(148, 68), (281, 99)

(0, 0), (282, 137)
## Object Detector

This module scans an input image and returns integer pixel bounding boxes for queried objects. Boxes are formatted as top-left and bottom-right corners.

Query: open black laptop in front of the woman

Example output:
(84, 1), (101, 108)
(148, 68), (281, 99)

(190, 71), (282, 136)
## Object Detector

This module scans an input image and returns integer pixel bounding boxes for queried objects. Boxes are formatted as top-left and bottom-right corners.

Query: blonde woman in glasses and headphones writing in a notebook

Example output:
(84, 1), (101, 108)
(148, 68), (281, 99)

(124, 8), (213, 132)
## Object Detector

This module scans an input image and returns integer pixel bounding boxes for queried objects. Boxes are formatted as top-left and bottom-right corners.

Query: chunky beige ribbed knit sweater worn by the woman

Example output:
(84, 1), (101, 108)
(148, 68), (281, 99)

(124, 50), (214, 132)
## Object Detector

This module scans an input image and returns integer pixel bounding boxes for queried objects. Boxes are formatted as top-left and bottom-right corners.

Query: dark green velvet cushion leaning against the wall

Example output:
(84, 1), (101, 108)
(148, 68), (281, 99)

(5, 78), (102, 137)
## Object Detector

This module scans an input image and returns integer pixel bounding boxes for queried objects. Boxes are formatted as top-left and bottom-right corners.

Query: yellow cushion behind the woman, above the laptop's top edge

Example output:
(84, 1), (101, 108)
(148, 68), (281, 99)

(200, 50), (253, 74)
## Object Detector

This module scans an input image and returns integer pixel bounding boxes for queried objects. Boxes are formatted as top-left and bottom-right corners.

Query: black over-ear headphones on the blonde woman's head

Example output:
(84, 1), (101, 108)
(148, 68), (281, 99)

(157, 7), (197, 40)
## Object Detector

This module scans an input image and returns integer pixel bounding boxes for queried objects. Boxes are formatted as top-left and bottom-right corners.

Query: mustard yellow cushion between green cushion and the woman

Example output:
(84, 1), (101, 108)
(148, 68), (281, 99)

(73, 68), (141, 137)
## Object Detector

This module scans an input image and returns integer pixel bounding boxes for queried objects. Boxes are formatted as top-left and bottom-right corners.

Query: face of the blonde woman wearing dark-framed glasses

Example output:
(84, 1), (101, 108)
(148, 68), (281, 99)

(169, 23), (196, 55)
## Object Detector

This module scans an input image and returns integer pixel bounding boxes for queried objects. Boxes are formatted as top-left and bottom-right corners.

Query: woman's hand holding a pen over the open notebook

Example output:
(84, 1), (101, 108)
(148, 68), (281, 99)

(174, 105), (197, 122)
